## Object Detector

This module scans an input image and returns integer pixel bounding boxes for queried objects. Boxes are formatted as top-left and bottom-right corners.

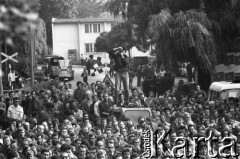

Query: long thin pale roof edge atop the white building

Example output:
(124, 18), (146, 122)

(52, 18), (122, 24)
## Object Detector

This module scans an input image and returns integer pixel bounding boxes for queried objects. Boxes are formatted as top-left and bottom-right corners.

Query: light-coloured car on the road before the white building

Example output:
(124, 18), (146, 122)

(58, 60), (74, 81)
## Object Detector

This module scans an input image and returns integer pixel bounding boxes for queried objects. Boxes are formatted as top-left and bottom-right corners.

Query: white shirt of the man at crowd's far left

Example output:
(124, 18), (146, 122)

(7, 105), (24, 120)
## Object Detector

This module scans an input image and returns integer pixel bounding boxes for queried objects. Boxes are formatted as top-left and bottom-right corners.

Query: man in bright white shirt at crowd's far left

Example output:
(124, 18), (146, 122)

(7, 97), (24, 121)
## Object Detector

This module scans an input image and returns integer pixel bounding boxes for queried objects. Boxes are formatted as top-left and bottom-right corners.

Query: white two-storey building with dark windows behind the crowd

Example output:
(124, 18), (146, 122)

(52, 18), (120, 60)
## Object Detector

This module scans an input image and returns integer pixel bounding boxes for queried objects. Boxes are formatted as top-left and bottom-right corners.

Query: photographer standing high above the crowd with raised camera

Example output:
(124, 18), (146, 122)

(108, 47), (129, 103)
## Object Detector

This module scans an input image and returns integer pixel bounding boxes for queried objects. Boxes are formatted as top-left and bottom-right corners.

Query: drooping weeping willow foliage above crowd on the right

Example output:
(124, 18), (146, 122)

(148, 10), (216, 70)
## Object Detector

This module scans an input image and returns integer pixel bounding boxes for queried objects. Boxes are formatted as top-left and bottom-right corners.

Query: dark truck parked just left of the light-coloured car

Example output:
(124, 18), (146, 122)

(44, 55), (64, 79)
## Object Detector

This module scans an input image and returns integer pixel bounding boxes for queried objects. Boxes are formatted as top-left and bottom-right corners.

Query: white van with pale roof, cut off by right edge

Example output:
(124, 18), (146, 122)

(208, 81), (240, 101)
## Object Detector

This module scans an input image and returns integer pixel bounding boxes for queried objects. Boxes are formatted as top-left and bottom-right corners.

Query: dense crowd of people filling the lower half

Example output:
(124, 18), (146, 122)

(0, 77), (240, 159)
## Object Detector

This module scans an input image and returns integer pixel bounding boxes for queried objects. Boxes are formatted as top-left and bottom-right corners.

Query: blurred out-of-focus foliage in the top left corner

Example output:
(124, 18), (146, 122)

(0, 0), (38, 46)
